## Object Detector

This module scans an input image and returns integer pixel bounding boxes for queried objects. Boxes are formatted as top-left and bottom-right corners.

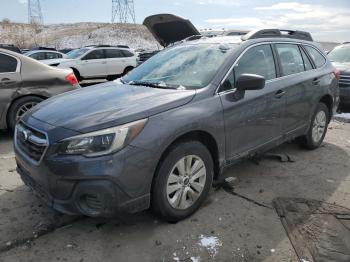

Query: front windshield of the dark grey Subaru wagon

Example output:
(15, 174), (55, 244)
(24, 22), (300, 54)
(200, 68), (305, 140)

(123, 44), (237, 89)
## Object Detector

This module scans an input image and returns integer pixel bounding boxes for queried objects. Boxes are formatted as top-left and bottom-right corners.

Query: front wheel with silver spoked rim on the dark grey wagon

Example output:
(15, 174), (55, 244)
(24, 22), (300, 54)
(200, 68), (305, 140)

(151, 141), (214, 222)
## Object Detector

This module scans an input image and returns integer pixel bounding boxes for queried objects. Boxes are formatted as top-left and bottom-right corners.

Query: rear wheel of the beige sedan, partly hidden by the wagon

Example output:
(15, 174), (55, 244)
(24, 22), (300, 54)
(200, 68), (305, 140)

(7, 96), (43, 131)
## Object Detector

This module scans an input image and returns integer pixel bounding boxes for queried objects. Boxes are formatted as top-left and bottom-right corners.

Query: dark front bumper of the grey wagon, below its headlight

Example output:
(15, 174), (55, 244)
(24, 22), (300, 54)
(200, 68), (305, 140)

(15, 143), (154, 217)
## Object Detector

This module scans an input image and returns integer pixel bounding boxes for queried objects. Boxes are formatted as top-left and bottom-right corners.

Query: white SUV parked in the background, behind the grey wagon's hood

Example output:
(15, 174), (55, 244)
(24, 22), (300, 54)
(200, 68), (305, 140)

(55, 45), (137, 80)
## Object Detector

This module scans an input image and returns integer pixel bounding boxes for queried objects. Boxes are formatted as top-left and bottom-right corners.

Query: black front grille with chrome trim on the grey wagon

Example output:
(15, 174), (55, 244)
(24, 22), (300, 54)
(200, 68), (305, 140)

(15, 123), (48, 163)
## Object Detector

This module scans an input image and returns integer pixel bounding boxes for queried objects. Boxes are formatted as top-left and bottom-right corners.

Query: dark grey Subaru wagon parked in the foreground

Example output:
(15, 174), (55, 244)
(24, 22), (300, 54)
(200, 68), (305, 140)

(15, 20), (339, 221)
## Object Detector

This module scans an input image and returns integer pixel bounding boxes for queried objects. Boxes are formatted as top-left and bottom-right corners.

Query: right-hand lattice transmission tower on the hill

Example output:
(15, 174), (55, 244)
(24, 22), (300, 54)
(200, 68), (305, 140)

(112, 0), (136, 24)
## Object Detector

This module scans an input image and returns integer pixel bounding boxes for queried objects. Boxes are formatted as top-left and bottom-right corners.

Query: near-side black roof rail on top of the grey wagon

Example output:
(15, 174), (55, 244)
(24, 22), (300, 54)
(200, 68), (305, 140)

(241, 29), (313, 41)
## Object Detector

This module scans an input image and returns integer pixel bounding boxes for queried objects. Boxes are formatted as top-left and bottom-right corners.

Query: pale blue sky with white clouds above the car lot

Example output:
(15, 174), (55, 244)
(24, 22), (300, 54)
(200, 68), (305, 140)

(0, 0), (350, 42)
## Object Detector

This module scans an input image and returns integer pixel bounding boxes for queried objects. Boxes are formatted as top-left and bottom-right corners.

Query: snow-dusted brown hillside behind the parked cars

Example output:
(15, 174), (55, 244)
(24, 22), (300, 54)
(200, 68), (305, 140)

(0, 22), (158, 49)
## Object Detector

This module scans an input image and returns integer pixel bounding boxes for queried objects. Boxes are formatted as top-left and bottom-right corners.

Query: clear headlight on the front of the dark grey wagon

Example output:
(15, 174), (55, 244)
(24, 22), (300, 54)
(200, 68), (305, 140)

(57, 119), (147, 157)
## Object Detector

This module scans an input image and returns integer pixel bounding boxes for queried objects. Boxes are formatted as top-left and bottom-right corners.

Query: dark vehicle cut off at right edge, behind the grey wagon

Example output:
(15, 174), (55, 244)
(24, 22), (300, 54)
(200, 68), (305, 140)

(328, 43), (350, 106)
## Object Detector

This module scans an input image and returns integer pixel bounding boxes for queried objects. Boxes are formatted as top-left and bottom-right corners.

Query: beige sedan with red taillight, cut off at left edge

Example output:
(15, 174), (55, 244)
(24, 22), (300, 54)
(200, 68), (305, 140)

(0, 49), (79, 129)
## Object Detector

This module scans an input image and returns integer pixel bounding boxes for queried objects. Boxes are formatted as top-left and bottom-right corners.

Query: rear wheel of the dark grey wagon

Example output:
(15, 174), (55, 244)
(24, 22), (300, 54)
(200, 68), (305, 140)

(298, 103), (330, 150)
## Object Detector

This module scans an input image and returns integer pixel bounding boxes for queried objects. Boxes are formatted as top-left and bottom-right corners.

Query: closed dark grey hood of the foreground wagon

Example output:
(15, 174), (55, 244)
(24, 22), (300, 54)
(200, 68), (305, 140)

(24, 82), (196, 133)
